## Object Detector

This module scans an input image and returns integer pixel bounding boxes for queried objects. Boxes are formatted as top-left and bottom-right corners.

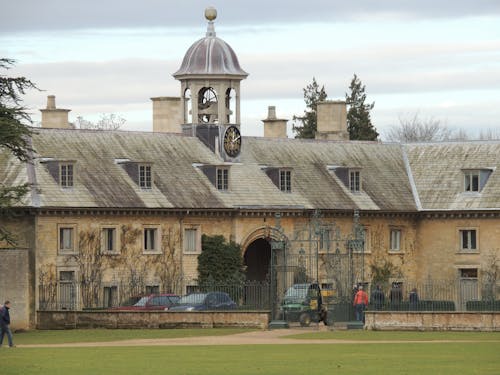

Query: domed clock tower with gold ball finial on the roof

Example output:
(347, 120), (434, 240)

(173, 7), (248, 161)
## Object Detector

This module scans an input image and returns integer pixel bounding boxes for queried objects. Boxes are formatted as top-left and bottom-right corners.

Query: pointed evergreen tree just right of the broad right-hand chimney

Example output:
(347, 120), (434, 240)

(345, 74), (378, 141)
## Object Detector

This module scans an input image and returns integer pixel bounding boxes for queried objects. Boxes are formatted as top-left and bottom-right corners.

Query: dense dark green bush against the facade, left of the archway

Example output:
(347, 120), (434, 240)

(198, 234), (245, 288)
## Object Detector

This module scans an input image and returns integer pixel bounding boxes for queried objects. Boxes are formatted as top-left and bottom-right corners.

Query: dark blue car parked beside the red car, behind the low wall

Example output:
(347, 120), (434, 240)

(169, 292), (236, 311)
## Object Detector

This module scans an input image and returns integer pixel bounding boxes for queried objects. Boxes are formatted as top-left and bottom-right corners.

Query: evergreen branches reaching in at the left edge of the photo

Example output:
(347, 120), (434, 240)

(0, 58), (36, 246)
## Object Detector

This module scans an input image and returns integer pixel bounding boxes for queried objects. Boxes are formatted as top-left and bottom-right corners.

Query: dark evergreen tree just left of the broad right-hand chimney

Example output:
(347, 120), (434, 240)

(293, 77), (327, 138)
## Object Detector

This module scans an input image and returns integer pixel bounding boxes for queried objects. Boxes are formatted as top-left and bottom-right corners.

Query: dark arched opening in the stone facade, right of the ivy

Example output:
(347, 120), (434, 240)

(244, 238), (271, 281)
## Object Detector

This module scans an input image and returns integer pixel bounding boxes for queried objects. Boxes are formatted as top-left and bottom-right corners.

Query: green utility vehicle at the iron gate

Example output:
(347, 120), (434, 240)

(280, 283), (333, 327)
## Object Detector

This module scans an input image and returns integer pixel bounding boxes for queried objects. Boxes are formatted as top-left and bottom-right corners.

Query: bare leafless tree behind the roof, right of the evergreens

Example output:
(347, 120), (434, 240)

(387, 112), (454, 142)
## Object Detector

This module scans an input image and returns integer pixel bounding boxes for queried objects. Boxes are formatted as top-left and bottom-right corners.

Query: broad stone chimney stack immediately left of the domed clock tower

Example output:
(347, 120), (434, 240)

(151, 96), (183, 133)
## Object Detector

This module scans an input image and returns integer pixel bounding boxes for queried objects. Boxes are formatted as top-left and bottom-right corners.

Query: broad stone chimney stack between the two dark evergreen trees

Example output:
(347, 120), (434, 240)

(316, 100), (349, 141)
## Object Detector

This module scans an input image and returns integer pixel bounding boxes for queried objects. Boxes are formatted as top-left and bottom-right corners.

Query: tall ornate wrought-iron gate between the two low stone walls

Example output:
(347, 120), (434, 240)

(269, 211), (365, 325)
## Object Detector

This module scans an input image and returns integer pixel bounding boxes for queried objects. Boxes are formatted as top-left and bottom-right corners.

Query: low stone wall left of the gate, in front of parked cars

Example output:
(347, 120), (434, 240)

(37, 311), (269, 329)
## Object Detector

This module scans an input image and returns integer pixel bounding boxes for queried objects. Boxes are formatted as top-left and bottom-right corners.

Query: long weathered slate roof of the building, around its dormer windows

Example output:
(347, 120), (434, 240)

(0, 129), (500, 212)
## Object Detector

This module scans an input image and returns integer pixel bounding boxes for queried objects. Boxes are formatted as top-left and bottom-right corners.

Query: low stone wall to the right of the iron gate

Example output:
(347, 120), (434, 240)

(365, 311), (500, 332)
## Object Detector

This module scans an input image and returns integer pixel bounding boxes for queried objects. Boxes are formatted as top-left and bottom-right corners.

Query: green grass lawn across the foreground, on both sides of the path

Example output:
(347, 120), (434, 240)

(0, 329), (500, 375)
